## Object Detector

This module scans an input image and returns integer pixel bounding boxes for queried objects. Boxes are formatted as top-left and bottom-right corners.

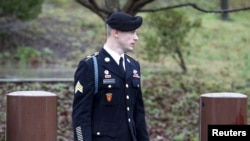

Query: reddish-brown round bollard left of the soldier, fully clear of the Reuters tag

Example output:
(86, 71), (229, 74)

(6, 91), (57, 141)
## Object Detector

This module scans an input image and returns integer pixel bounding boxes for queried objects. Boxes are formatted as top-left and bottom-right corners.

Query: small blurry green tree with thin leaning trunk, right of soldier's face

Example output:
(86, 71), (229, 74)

(144, 10), (201, 73)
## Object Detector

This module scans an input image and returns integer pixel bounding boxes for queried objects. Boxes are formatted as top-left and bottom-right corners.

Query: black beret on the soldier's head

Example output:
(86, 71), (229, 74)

(106, 12), (142, 31)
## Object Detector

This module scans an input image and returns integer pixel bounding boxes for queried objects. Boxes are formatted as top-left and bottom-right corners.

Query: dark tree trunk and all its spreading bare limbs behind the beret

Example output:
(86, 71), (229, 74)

(76, 0), (250, 21)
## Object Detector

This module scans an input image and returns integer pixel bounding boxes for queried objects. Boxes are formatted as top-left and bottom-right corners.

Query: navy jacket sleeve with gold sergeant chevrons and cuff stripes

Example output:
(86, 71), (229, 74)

(72, 60), (94, 141)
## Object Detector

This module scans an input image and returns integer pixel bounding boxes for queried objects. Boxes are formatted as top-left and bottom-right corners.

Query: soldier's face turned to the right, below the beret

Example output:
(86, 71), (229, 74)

(118, 30), (139, 52)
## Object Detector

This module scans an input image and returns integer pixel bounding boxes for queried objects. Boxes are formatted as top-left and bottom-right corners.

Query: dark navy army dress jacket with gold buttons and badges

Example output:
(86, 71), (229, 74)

(72, 49), (149, 141)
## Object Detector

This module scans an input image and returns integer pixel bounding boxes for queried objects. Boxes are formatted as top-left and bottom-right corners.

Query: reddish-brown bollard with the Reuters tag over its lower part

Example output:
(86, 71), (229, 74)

(199, 93), (247, 141)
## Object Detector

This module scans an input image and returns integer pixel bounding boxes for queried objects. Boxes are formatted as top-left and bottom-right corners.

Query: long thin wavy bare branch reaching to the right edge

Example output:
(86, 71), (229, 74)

(138, 3), (250, 13)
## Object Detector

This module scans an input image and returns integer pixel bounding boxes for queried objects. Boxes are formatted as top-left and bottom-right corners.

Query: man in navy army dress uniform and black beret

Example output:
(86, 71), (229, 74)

(72, 12), (149, 141)
